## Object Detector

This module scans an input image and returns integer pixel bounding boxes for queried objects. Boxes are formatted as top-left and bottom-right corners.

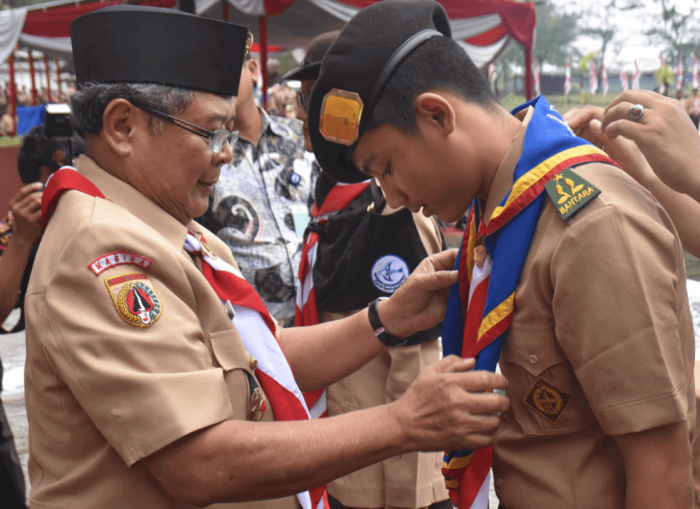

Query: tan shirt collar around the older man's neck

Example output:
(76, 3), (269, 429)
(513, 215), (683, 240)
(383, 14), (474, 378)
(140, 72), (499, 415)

(75, 155), (197, 248)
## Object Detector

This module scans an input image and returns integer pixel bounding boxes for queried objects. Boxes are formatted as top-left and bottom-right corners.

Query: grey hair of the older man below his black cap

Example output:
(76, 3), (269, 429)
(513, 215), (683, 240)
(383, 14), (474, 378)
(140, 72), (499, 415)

(70, 83), (195, 136)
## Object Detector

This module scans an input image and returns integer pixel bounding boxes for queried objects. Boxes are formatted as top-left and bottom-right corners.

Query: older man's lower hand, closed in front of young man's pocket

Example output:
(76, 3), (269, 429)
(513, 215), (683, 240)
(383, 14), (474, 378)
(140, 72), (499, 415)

(389, 355), (510, 451)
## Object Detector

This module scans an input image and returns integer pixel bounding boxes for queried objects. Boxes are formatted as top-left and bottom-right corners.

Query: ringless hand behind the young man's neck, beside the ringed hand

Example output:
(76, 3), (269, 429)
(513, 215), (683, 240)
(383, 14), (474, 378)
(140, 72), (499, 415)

(564, 106), (654, 187)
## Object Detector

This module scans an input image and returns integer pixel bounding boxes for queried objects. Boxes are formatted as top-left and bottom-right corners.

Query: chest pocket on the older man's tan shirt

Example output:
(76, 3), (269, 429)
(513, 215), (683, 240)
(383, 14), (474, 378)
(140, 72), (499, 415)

(208, 329), (255, 421)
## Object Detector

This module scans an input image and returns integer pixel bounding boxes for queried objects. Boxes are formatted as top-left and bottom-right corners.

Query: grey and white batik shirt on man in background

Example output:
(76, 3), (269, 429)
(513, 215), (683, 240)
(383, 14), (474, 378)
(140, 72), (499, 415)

(197, 110), (318, 326)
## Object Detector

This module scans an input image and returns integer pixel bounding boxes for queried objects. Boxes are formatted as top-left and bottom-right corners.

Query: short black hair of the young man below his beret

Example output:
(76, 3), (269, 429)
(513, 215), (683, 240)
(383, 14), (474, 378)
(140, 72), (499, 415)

(368, 37), (498, 134)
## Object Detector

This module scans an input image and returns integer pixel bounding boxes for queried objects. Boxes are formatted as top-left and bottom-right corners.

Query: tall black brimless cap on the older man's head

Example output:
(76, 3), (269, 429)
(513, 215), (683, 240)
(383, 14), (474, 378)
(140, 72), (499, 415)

(70, 5), (248, 96)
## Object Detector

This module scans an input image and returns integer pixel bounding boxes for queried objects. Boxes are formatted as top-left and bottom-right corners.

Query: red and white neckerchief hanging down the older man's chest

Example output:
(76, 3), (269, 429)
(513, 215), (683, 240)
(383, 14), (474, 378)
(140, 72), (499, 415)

(184, 233), (329, 509)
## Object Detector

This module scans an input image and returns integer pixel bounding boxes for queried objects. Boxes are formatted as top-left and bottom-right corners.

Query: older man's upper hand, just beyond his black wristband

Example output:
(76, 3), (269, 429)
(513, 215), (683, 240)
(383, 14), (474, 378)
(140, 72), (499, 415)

(377, 249), (458, 338)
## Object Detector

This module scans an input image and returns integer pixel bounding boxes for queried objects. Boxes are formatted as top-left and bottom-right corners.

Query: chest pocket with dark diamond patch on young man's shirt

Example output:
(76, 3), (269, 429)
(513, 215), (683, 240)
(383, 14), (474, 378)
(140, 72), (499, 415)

(501, 323), (596, 435)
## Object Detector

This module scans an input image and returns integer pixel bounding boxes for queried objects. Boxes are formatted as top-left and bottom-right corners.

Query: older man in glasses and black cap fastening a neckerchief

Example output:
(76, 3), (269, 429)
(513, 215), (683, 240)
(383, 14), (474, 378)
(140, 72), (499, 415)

(25, 6), (508, 509)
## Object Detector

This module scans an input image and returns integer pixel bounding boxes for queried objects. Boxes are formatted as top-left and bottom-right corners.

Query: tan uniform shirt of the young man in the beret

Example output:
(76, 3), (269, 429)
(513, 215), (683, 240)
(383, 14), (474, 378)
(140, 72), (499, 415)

(486, 109), (695, 509)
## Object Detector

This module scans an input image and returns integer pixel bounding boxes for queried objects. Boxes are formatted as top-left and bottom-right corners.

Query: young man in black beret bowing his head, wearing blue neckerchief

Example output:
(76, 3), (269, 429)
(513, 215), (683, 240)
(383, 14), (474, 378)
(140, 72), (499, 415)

(309, 0), (695, 509)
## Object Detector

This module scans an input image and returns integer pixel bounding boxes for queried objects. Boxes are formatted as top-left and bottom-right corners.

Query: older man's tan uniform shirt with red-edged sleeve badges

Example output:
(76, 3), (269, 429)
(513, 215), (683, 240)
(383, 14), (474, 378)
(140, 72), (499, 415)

(25, 156), (299, 509)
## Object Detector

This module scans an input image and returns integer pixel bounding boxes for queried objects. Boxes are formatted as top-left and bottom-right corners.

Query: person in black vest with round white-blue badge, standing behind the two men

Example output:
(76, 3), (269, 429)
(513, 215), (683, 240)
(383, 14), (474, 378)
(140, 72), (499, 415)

(284, 31), (451, 509)
